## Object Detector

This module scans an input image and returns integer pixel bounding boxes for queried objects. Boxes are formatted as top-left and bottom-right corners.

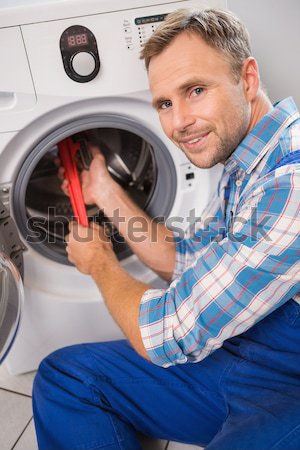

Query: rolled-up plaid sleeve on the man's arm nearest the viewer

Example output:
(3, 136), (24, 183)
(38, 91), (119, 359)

(140, 169), (300, 367)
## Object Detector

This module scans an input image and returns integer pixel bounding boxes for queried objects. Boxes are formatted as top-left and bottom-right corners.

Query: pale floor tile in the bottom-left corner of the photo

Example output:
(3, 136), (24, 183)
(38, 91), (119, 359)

(0, 389), (32, 450)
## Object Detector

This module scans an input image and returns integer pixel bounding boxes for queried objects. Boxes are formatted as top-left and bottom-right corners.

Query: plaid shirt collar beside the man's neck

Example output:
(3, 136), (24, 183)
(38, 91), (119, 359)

(224, 97), (300, 173)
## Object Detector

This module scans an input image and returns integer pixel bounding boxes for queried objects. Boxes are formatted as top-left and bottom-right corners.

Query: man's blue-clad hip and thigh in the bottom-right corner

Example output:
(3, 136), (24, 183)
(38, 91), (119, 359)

(207, 301), (300, 450)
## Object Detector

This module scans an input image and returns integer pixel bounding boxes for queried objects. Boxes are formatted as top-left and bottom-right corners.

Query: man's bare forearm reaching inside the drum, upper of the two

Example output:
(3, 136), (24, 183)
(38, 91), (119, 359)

(60, 146), (175, 280)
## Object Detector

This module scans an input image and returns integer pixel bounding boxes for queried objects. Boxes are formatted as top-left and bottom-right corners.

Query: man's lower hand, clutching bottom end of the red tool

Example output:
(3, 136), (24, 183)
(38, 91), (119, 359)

(65, 222), (118, 275)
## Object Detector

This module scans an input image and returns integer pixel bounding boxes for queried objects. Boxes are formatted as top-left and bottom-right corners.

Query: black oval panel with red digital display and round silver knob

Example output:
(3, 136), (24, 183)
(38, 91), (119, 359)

(60, 25), (100, 83)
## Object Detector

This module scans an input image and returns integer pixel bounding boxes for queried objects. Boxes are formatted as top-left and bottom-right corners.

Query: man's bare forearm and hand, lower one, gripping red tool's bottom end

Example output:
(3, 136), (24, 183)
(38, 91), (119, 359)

(66, 222), (150, 359)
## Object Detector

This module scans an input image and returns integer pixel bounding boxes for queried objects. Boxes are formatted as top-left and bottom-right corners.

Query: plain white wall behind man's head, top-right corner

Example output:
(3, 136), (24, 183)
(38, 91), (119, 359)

(228, 0), (300, 108)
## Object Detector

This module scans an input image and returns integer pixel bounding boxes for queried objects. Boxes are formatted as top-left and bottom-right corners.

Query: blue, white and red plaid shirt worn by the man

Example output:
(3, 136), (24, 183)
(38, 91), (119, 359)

(139, 97), (300, 367)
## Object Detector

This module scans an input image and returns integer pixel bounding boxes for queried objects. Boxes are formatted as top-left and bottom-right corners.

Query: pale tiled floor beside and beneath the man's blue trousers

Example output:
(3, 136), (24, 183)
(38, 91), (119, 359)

(0, 364), (200, 450)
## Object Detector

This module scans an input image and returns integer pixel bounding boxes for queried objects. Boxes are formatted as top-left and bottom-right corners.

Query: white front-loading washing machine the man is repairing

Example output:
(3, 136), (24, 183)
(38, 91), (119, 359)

(0, 0), (226, 374)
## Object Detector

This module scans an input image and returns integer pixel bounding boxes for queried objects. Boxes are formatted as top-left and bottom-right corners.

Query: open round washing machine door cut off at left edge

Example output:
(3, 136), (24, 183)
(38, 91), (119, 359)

(0, 201), (24, 364)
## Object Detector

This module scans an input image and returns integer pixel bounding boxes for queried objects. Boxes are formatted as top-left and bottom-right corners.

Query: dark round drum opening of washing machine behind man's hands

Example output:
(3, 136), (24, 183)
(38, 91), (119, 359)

(14, 127), (176, 264)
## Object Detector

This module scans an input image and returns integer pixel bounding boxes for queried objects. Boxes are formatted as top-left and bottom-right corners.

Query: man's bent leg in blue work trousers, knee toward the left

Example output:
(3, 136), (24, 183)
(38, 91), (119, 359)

(33, 341), (235, 450)
